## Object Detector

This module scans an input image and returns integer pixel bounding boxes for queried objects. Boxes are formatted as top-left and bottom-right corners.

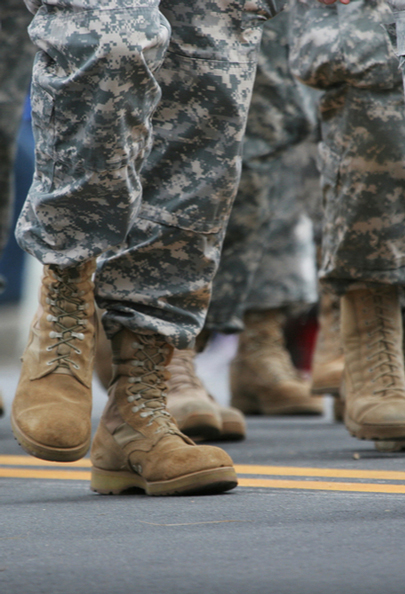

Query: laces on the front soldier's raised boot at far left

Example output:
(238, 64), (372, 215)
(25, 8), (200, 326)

(46, 270), (89, 369)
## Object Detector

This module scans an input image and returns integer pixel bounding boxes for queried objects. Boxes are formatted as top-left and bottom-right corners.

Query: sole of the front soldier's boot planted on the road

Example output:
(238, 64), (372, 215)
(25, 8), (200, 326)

(90, 466), (238, 496)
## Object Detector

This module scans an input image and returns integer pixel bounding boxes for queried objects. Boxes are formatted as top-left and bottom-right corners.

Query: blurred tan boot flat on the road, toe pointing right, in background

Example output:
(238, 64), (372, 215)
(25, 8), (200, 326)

(230, 309), (323, 415)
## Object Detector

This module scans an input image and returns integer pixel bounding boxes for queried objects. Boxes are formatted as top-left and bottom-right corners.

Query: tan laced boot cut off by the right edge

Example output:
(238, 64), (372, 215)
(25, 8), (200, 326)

(341, 285), (405, 440)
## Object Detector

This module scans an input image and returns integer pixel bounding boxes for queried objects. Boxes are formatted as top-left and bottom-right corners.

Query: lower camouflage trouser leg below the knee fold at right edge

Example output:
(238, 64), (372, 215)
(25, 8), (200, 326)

(320, 87), (405, 293)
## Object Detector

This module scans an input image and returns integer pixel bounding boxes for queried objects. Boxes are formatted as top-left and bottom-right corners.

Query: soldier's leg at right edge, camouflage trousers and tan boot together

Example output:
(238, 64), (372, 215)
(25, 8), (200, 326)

(288, 1), (405, 440)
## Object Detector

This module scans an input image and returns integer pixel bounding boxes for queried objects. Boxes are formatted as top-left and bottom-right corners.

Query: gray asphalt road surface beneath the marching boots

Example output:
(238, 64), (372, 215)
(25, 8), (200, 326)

(0, 341), (405, 594)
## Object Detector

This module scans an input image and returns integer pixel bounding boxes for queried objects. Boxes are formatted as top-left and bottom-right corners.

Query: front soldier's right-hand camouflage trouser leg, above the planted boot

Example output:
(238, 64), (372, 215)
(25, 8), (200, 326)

(97, 0), (269, 348)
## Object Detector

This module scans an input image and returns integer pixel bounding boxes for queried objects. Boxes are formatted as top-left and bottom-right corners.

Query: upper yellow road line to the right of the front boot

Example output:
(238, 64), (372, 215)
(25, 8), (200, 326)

(235, 464), (405, 481)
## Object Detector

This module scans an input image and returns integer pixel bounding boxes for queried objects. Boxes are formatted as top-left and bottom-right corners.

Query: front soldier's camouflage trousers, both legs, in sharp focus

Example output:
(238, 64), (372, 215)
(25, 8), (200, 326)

(16, 0), (275, 348)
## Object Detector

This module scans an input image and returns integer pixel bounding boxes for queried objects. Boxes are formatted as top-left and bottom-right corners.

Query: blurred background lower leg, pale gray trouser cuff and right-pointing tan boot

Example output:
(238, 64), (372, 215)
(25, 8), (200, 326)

(230, 197), (323, 415)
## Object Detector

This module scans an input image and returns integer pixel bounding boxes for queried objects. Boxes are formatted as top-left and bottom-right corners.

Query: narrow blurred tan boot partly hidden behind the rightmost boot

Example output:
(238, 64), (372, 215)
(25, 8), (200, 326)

(311, 292), (344, 397)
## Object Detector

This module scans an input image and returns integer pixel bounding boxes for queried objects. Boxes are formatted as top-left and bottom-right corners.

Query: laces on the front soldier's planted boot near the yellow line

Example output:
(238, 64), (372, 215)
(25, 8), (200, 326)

(127, 335), (172, 433)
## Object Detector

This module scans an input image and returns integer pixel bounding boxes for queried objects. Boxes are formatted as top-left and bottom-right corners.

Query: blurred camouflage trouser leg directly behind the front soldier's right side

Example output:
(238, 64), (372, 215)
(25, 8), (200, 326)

(206, 13), (318, 332)
